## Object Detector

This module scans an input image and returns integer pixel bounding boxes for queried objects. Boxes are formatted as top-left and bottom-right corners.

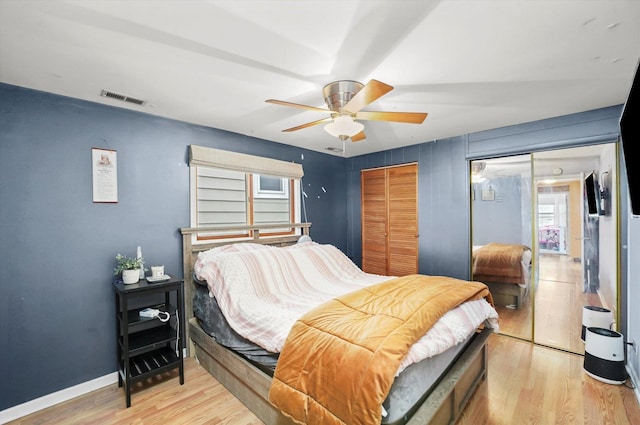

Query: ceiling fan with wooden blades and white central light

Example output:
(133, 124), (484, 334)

(266, 80), (427, 142)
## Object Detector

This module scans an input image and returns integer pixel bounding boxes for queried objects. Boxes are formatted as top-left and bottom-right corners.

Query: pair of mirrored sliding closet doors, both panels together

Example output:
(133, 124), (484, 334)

(471, 143), (618, 354)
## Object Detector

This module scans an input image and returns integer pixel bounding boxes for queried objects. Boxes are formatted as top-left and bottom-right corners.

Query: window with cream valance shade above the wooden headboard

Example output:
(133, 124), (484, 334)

(189, 146), (302, 242)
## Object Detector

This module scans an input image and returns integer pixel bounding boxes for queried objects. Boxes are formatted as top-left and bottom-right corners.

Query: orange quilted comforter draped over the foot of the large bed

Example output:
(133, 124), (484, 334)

(269, 275), (493, 425)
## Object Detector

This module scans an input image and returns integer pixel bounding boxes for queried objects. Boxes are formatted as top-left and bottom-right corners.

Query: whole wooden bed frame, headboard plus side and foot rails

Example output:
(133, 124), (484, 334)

(180, 223), (492, 425)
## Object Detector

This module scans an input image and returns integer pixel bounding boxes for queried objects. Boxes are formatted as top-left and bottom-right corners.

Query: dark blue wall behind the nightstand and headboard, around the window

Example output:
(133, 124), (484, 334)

(0, 84), (346, 410)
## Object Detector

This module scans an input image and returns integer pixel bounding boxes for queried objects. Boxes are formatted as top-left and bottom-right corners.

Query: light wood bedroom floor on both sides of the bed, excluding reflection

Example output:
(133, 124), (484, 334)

(10, 334), (640, 425)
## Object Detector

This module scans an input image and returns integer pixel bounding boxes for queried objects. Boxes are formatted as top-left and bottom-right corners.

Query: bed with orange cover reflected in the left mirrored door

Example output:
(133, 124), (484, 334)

(472, 242), (531, 310)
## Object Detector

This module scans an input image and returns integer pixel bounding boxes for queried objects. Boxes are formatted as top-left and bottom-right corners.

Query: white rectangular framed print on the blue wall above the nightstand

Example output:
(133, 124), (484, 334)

(91, 148), (118, 203)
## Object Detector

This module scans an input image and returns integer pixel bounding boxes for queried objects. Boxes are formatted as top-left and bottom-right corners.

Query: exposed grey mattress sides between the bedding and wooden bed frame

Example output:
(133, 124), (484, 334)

(193, 285), (473, 425)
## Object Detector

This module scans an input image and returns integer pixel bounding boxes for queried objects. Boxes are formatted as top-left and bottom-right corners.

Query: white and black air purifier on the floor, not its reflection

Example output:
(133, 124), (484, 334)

(583, 327), (627, 385)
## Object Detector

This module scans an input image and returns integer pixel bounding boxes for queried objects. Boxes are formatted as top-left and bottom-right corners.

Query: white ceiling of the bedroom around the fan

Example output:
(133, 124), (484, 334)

(0, 0), (640, 157)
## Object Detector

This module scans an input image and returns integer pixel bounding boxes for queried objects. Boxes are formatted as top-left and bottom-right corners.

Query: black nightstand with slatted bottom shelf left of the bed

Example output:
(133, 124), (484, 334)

(113, 275), (185, 407)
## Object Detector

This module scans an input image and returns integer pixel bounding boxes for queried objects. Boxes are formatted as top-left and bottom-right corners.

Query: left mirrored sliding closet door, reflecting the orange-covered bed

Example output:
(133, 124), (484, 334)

(471, 155), (533, 340)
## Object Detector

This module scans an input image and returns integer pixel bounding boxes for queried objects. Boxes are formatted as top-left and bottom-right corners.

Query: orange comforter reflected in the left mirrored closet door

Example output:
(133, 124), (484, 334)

(473, 243), (529, 285)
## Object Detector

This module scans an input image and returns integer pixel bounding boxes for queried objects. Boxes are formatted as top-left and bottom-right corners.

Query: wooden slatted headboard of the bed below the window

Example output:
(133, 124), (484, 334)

(180, 223), (311, 356)
